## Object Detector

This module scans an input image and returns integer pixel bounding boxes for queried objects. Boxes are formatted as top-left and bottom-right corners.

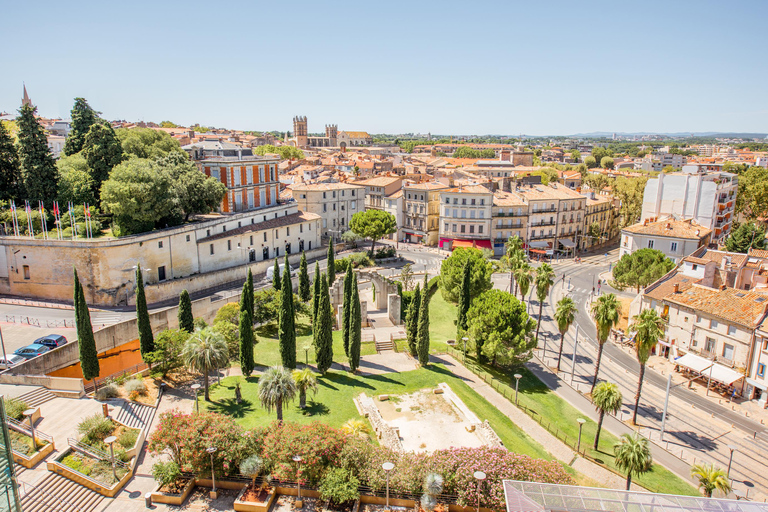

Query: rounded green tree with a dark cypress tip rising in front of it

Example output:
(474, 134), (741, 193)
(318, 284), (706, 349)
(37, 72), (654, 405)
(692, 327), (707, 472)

(440, 247), (493, 303)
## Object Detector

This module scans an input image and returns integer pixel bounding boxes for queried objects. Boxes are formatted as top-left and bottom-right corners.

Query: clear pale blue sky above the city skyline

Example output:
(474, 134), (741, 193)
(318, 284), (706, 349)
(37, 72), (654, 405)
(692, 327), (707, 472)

(0, 0), (768, 135)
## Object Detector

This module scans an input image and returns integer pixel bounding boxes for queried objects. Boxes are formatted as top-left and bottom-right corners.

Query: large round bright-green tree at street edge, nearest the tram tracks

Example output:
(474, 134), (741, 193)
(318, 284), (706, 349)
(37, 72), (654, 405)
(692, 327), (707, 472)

(467, 290), (536, 364)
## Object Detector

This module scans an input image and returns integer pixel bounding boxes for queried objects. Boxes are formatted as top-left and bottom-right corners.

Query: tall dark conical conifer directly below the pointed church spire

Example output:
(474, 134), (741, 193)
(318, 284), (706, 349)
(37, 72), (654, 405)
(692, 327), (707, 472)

(16, 105), (59, 206)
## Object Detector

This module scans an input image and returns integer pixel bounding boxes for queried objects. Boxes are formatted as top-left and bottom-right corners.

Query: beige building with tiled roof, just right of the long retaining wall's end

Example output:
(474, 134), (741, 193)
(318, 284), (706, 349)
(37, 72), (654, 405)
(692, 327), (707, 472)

(290, 183), (365, 239)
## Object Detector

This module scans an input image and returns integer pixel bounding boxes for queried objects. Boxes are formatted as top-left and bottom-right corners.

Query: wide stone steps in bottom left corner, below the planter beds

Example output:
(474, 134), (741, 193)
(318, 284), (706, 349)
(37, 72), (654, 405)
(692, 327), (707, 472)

(21, 473), (104, 512)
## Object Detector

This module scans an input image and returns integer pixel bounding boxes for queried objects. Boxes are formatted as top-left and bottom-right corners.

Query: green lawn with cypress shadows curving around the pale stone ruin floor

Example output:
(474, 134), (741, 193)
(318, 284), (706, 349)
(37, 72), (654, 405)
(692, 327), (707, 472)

(200, 365), (551, 459)
